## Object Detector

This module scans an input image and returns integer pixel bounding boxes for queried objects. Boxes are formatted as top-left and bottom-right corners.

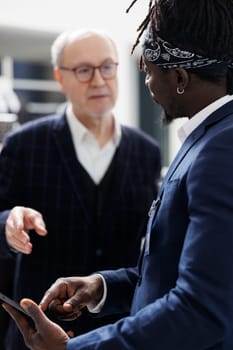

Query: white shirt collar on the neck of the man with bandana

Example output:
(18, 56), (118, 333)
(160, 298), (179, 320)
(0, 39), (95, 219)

(177, 95), (233, 143)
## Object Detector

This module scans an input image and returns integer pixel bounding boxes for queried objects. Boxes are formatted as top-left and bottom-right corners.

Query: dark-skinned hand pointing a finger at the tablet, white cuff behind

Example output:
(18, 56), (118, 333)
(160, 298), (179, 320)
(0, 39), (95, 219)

(40, 275), (103, 321)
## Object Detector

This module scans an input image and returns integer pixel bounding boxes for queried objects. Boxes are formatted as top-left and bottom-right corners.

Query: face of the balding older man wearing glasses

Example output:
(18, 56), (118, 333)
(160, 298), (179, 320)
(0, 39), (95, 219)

(55, 33), (118, 119)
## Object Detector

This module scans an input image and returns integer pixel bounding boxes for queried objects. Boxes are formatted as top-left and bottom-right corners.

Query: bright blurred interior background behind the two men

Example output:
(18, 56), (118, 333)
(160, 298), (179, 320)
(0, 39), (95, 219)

(0, 0), (184, 169)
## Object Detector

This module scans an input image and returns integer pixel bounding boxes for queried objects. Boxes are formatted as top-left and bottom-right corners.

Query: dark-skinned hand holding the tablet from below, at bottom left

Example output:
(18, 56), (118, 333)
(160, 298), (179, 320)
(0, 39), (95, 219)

(3, 299), (69, 350)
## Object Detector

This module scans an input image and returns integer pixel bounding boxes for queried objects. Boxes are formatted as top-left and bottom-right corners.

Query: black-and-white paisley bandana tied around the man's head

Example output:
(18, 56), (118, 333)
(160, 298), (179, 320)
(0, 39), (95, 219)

(143, 28), (233, 69)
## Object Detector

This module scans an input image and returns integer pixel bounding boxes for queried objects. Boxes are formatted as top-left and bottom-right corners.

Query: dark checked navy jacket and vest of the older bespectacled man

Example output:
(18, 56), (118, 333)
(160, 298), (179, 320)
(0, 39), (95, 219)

(0, 115), (161, 350)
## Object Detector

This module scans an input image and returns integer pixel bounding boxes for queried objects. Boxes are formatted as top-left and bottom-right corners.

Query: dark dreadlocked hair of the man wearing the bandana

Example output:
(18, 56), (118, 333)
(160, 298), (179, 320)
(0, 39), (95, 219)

(126, 0), (233, 94)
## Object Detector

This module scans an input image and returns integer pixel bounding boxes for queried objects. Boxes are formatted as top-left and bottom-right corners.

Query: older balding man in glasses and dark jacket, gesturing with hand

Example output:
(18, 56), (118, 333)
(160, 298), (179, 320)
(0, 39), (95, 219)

(0, 30), (161, 350)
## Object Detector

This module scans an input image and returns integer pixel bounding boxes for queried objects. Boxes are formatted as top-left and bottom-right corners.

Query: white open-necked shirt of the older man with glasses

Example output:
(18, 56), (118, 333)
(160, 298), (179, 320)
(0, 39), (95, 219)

(66, 104), (121, 184)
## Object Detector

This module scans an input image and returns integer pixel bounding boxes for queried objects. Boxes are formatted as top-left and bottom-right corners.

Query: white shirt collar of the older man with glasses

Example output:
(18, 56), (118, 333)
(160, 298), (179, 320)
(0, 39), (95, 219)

(66, 103), (122, 147)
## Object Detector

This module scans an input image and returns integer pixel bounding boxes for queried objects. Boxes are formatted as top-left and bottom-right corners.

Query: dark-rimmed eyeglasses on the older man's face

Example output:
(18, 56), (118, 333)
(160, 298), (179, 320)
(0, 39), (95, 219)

(59, 62), (118, 83)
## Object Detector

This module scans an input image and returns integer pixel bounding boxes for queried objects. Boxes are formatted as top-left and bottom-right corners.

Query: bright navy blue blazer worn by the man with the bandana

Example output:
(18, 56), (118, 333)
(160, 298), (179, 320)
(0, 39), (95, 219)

(67, 102), (233, 350)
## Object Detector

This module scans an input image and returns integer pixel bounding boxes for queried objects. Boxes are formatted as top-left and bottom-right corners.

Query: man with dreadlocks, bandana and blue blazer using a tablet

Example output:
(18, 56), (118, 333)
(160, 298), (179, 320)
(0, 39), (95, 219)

(4, 0), (233, 350)
